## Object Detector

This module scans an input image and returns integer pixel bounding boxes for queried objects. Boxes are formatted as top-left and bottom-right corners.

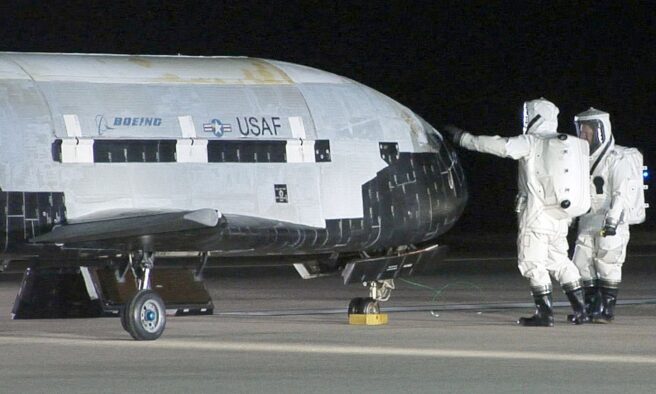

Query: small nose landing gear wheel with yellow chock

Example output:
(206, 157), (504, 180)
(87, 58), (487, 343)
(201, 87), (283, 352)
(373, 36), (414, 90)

(348, 279), (394, 325)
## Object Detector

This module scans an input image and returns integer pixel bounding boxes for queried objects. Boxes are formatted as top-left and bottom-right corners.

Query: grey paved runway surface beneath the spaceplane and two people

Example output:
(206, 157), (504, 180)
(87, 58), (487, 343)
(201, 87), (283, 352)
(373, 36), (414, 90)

(0, 245), (656, 393)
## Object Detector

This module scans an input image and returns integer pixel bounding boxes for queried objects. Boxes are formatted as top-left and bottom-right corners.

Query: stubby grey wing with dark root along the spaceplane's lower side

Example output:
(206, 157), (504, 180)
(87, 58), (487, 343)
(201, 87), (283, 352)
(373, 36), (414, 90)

(30, 208), (325, 254)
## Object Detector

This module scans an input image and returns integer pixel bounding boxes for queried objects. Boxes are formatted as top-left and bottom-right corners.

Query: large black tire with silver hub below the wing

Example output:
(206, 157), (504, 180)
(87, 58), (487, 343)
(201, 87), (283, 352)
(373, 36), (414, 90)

(125, 290), (166, 341)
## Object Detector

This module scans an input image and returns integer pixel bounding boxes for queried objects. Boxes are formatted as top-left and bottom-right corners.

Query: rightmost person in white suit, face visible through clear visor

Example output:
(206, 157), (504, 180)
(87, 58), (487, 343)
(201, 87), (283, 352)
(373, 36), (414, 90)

(573, 108), (631, 323)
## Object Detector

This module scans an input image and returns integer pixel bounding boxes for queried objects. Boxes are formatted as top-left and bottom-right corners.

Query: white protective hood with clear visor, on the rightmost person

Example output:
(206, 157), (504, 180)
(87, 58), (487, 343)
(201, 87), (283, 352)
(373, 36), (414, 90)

(574, 108), (615, 161)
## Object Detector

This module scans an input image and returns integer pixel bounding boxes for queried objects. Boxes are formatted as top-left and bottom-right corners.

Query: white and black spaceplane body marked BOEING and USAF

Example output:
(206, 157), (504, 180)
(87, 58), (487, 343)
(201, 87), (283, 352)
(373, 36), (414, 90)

(0, 53), (467, 340)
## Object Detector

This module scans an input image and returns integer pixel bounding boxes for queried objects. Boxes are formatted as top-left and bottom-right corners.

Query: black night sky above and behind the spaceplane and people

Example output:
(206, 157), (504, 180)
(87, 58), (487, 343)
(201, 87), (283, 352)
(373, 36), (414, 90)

(0, 1), (656, 231)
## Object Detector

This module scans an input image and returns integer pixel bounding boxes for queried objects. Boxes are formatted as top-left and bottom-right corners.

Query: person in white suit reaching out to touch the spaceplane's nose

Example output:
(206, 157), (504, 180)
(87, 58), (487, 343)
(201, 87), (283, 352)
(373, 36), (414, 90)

(443, 98), (589, 327)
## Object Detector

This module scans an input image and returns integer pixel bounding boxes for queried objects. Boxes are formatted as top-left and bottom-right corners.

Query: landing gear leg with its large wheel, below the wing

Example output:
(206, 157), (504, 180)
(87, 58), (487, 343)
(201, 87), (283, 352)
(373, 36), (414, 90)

(121, 252), (166, 341)
